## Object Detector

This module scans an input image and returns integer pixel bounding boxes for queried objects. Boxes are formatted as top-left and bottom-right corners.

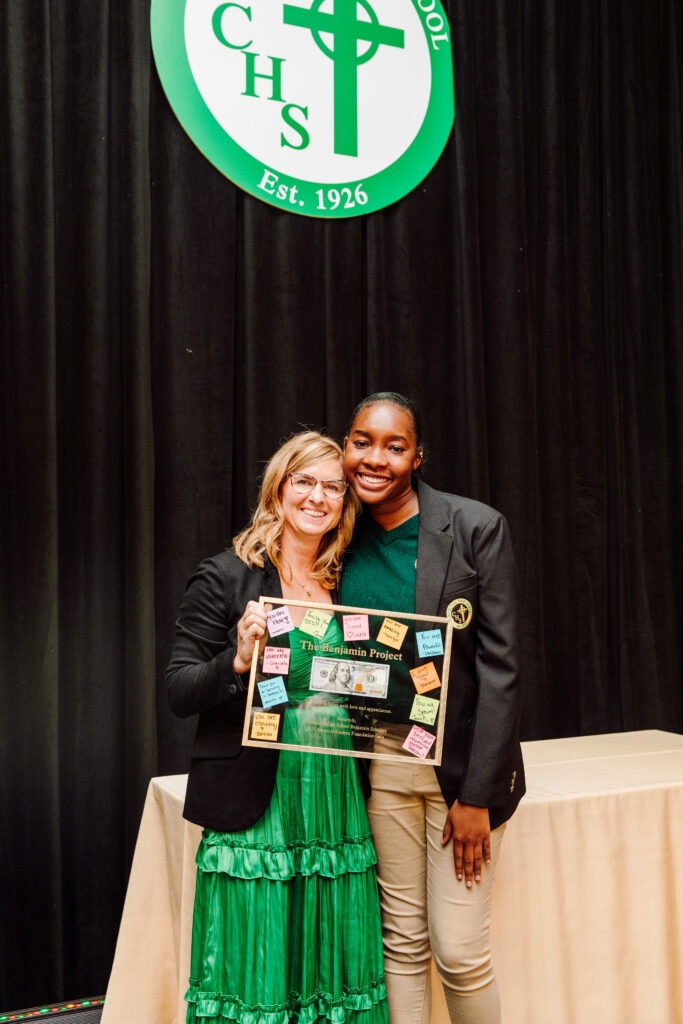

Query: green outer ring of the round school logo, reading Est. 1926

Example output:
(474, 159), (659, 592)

(150, 0), (455, 219)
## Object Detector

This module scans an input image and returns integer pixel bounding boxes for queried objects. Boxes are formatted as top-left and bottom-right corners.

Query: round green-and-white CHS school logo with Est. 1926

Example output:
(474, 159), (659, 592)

(152, 0), (454, 217)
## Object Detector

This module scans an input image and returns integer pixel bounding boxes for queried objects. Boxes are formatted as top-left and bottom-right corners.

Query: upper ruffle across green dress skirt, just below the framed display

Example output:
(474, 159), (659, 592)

(197, 834), (377, 882)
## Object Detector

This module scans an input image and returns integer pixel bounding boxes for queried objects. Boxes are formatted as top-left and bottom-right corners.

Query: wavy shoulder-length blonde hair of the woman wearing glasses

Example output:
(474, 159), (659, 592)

(232, 430), (360, 590)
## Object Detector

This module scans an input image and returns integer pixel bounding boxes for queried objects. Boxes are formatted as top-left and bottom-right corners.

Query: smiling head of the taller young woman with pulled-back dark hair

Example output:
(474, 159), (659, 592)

(344, 401), (422, 515)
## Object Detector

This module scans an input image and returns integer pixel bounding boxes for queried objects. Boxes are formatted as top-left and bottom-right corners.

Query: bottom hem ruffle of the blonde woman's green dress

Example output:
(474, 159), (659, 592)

(185, 978), (386, 1024)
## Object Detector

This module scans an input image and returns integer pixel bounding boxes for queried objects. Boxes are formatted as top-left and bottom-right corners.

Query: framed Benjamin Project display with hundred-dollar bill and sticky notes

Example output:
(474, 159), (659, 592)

(242, 596), (454, 765)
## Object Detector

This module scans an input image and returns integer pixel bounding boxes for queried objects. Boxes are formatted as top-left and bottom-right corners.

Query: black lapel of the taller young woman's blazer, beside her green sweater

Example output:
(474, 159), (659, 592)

(415, 479), (453, 615)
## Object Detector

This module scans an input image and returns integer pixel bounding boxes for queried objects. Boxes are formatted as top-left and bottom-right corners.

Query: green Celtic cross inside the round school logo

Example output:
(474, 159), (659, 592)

(283, 0), (403, 157)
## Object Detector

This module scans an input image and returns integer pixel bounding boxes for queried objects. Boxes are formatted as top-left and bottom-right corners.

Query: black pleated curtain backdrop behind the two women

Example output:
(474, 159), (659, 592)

(0, 0), (683, 1012)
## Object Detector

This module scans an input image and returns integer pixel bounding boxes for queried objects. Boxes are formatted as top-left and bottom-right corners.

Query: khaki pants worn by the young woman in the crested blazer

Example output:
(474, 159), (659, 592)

(368, 760), (505, 1024)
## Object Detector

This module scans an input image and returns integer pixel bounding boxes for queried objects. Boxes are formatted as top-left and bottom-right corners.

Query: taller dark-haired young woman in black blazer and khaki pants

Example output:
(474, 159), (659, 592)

(341, 392), (524, 1024)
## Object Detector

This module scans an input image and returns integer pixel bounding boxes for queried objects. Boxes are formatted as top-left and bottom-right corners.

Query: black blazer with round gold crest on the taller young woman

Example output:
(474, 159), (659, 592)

(415, 480), (525, 828)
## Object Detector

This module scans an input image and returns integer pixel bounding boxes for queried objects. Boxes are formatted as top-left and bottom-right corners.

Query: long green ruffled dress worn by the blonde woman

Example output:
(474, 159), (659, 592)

(185, 620), (387, 1024)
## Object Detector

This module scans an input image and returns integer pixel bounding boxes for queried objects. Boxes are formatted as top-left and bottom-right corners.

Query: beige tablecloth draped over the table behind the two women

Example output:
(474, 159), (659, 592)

(102, 730), (683, 1024)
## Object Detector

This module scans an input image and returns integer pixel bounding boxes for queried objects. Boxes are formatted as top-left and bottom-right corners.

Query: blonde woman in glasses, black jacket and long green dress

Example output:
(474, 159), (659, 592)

(166, 431), (387, 1024)
